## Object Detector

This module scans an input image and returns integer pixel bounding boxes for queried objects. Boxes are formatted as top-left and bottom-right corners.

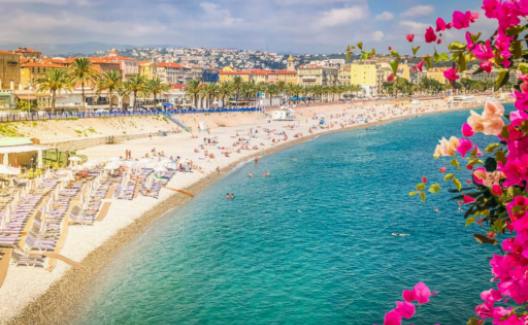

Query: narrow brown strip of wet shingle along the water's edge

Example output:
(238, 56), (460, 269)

(7, 97), (492, 324)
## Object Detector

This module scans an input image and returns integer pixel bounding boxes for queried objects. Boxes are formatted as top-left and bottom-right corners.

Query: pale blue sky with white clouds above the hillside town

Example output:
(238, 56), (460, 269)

(0, 0), (490, 53)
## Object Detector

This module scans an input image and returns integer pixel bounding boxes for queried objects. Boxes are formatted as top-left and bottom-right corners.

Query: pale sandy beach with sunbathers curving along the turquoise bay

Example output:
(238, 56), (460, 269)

(0, 97), (492, 324)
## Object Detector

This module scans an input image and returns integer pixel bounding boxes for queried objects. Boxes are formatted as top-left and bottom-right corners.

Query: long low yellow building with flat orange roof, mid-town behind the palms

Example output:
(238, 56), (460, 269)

(219, 67), (297, 84)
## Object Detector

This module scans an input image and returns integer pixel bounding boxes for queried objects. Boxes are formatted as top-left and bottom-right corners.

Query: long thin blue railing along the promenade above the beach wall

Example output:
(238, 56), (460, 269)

(0, 107), (262, 123)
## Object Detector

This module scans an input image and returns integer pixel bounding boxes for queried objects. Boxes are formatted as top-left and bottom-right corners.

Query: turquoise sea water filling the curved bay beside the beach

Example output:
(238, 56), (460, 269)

(75, 112), (494, 324)
